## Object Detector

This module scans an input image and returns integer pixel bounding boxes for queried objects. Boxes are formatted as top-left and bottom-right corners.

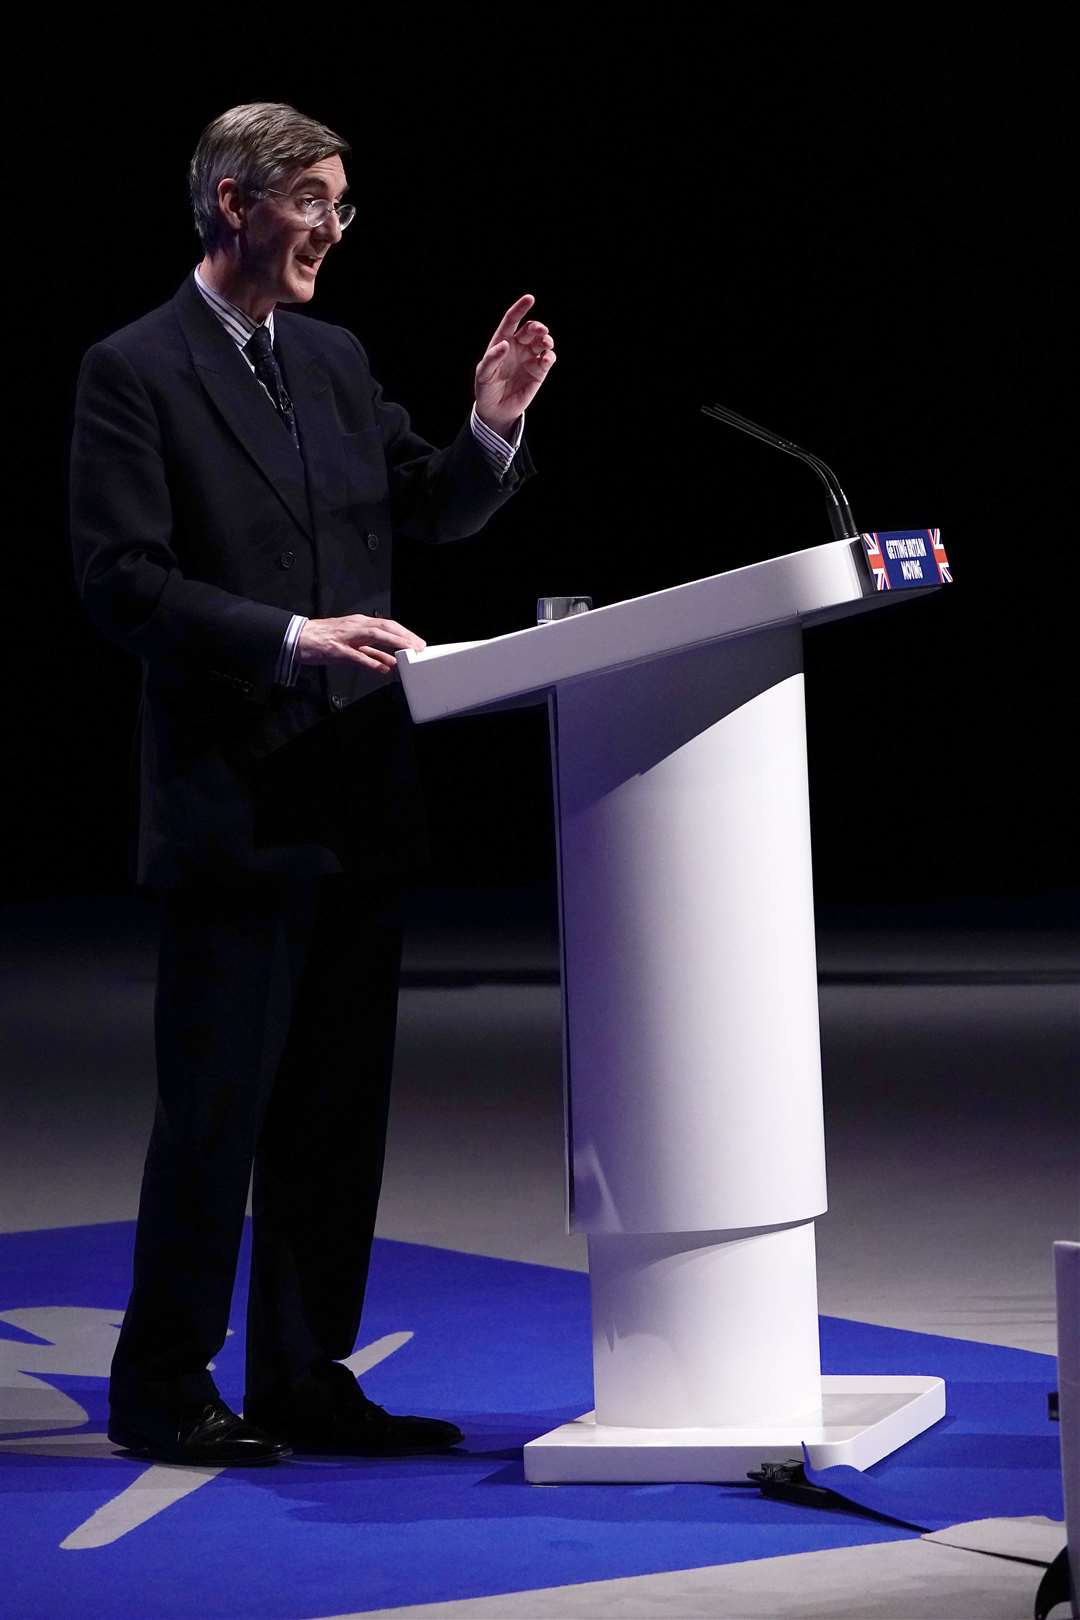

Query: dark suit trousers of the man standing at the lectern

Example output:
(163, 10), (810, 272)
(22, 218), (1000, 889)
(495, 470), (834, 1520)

(110, 878), (402, 1419)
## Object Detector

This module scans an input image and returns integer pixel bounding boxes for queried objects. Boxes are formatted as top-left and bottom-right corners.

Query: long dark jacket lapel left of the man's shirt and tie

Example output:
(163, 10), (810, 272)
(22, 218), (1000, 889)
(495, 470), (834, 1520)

(175, 275), (314, 539)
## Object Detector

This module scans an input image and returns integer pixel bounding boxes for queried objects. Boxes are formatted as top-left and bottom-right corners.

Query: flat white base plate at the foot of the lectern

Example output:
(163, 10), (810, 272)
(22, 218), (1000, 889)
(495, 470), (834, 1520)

(525, 1375), (946, 1486)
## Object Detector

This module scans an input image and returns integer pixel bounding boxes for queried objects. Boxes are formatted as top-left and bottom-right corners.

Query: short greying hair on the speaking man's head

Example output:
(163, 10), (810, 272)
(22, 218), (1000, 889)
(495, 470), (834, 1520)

(188, 102), (350, 253)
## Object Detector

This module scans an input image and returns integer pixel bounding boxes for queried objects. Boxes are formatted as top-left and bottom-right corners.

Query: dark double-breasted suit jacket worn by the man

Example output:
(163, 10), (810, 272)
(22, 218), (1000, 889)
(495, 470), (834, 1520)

(71, 277), (531, 888)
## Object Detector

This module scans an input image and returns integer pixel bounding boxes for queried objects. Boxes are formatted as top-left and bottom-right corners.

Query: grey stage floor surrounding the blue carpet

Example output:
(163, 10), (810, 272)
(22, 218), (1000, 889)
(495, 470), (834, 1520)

(0, 897), (1080, 1620)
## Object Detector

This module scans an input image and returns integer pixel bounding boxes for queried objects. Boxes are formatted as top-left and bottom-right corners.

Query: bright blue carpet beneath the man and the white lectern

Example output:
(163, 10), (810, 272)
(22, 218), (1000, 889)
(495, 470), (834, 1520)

(0, 1223), (1062, 1620)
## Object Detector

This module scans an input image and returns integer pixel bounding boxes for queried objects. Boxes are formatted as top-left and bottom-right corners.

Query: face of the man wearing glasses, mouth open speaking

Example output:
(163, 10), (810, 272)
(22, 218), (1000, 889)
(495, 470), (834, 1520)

(240, 156), (348, 303)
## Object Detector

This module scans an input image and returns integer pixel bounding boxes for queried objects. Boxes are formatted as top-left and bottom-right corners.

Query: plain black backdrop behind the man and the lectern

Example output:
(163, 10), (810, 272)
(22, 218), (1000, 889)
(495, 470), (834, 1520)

(5, 22), (1077, 914)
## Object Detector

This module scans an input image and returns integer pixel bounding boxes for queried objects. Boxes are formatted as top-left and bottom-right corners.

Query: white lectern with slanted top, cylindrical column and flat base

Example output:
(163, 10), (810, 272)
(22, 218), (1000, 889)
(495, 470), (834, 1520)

(398, 539), (946, 1484)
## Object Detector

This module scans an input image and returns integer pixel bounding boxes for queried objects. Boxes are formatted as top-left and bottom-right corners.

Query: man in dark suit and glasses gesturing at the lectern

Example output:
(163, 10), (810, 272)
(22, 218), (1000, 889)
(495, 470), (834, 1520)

(71, 104), (555, 1464)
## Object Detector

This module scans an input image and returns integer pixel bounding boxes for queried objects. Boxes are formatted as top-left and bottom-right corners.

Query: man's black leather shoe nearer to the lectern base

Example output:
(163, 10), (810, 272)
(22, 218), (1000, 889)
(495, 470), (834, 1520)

(244, 1362), (463, 1456)
